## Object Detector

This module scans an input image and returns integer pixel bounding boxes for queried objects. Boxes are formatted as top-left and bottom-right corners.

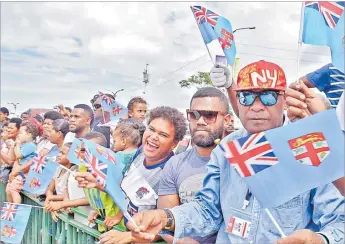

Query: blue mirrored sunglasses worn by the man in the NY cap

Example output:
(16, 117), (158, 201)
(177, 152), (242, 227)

(237, 91), (284, 106)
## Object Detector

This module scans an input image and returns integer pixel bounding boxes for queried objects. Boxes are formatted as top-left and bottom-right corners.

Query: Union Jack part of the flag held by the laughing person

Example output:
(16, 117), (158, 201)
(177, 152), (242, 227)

(85, 148), (108, 186)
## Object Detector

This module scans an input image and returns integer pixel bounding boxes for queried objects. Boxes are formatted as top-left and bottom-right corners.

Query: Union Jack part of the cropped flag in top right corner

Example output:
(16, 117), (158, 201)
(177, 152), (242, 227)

(305, 2), (344, 29)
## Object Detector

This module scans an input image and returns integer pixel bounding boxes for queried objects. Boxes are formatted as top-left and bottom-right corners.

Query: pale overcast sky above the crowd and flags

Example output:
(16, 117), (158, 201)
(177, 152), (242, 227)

(1, 2), (331, 115)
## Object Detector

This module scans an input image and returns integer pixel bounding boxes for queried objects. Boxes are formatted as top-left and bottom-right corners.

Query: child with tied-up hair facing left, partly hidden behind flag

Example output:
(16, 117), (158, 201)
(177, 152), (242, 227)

(80, 119), (145, 231)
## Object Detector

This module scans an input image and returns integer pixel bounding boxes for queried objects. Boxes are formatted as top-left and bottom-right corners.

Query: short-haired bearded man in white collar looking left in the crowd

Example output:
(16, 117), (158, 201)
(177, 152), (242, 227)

(64, 104), (94, 144)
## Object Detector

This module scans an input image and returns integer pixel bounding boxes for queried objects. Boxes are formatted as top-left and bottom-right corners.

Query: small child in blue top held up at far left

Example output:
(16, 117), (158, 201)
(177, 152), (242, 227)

(6, 121), (39, 203)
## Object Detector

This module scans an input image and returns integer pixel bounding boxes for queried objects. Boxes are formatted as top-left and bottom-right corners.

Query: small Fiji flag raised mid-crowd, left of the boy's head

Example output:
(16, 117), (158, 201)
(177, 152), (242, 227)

(99, 92), (128, 123)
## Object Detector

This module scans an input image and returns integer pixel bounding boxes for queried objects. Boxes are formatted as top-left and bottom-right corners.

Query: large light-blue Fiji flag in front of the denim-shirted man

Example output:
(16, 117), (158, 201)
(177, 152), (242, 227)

(222, 110), (344, 208)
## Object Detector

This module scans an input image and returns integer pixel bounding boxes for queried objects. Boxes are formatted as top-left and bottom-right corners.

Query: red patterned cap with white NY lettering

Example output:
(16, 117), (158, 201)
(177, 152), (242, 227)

(234, 60), (286, 91)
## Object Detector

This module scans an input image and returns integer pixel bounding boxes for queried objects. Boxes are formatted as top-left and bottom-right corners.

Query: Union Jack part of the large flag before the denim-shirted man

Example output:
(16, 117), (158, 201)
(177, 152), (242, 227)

(224, 132), (278, 177)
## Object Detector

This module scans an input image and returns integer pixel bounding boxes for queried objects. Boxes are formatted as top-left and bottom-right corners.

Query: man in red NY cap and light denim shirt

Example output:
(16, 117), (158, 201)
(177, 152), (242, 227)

(128, 60), (344, 244)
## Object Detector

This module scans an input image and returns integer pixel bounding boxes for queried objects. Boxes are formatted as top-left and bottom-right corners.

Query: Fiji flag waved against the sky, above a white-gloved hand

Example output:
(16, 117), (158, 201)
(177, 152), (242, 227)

(191, 6), (236, 65)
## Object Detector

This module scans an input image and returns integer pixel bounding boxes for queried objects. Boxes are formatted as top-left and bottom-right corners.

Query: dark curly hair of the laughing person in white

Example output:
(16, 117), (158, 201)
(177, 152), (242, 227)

(148, 106), (187, 141)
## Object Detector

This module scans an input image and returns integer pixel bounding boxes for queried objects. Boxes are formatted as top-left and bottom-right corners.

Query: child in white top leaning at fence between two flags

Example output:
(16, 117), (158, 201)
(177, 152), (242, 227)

(44, 143), (78, 220)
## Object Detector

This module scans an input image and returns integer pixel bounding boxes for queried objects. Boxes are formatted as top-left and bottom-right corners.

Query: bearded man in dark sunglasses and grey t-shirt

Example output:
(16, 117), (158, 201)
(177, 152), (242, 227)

(158, 87), (231, 243)
